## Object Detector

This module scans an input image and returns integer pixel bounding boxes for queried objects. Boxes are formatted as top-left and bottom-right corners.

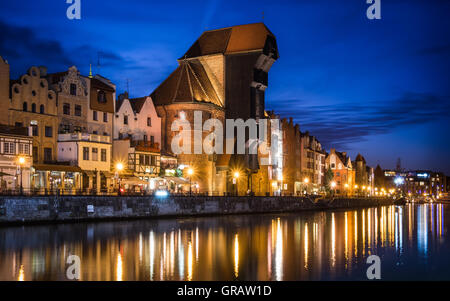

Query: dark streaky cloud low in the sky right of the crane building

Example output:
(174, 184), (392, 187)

(268, 93), (450, 149)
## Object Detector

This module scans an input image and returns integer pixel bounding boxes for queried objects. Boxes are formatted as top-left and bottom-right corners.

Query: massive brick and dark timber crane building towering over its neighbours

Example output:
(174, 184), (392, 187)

(150, 23), (278, 194)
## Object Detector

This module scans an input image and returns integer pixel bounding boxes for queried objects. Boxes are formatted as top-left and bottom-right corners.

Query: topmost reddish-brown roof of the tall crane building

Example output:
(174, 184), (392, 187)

(180, 23), (278, 59)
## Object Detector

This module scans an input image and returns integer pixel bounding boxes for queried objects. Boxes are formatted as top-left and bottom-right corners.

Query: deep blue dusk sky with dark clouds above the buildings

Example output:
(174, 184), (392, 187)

(0, 0), (450, 174)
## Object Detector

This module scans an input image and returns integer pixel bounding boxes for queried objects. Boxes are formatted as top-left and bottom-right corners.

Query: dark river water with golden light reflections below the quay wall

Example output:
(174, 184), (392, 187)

(0, 204), (450, 281)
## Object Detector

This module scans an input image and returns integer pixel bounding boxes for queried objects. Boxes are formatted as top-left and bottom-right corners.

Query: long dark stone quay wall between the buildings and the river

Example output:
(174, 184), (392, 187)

(0, 196), (394, 224)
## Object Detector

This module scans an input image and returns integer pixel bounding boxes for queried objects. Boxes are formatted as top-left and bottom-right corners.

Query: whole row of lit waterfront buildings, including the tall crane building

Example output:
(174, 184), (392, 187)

(0, 23), (448, 195)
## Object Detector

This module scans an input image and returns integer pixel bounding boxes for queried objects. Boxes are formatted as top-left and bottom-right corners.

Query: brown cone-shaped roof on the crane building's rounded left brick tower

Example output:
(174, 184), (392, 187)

(150, 60), (223, 107)
